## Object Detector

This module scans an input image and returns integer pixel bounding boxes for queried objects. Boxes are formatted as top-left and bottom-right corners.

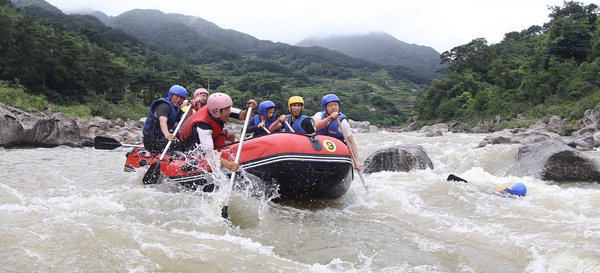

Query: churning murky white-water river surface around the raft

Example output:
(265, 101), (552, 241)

(0, 132), (600, 272)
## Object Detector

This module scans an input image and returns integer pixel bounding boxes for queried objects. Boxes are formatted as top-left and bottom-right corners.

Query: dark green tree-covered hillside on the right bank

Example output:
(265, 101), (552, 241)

(415, 2), (600, 129)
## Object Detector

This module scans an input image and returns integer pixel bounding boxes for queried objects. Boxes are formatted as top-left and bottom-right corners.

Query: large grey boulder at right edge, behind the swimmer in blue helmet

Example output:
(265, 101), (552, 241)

(517, 141), (600, 182)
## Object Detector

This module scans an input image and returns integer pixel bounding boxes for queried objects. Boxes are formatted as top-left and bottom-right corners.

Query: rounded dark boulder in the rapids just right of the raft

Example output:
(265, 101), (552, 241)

(363, 144), (433, 173)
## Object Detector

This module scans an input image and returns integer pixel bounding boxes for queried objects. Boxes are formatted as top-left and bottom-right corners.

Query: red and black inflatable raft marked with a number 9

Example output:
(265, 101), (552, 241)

(125, 133), (353, 199)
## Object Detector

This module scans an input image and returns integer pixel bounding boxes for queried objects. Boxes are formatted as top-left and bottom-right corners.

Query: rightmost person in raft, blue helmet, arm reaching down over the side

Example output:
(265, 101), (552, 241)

(313, 94), (362, 171)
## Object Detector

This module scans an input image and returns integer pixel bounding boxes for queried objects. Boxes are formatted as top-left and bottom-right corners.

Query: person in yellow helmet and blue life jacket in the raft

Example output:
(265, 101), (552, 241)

(269, 96), (317, 135)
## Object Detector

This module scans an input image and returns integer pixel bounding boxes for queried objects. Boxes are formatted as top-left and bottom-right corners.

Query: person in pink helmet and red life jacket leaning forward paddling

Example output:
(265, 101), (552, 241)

(179, 93), (256, 171)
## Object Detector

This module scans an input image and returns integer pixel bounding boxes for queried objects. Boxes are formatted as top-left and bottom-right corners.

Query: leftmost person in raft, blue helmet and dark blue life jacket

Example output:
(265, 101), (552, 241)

(142, 85), (187, 153)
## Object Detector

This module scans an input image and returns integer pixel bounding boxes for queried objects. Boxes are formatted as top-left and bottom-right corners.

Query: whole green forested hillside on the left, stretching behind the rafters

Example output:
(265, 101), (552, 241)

(0, 0), (426, 125)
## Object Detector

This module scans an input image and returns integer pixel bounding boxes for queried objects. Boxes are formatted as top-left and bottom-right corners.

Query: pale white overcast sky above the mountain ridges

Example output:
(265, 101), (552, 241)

(46, 0), (594, 53)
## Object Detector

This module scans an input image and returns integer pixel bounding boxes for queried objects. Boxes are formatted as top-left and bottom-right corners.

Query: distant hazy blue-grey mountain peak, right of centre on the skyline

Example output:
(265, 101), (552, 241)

(296, 32), (440, 78)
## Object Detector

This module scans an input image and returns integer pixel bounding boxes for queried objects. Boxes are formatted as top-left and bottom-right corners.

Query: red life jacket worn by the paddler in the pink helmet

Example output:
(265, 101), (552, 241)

(179, 106), (226, 148)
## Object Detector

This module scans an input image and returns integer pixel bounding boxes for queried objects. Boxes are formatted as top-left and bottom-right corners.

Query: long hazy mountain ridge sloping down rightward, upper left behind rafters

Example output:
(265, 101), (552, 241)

(101, 9), (379, 71)
